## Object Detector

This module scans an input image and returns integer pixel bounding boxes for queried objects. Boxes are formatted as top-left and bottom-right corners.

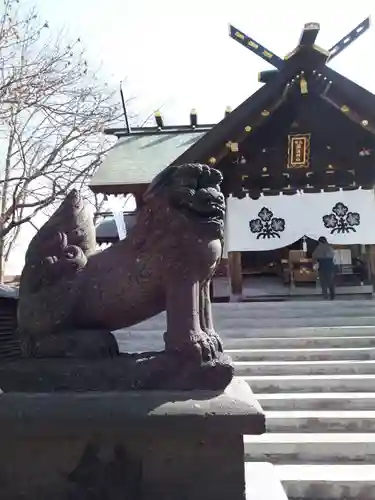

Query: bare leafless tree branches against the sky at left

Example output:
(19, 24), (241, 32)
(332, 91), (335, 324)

(0, 0), (128, 278)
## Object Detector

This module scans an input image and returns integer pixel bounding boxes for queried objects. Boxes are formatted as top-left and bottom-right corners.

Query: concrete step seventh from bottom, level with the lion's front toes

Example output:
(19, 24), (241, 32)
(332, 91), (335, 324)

(226, 341), (375, 361)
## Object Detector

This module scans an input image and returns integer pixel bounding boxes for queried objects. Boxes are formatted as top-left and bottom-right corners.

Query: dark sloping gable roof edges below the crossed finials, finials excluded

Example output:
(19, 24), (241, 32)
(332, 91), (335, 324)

(173, 69), (375, 169)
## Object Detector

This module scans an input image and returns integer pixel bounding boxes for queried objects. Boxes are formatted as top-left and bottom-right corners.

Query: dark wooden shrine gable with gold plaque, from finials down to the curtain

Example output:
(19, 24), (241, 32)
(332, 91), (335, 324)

(174, 20), (375, 196)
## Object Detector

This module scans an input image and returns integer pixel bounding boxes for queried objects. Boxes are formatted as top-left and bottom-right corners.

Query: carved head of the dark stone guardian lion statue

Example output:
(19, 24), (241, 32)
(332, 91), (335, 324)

(143, 163), (225, 233)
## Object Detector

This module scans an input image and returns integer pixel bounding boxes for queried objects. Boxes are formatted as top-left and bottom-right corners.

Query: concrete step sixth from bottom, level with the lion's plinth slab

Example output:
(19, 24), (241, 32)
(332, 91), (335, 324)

(234, 360), (375, 376)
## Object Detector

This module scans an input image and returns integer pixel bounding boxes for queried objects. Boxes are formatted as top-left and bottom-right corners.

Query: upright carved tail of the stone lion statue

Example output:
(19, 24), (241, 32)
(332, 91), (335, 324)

(18, 190), (96, 336)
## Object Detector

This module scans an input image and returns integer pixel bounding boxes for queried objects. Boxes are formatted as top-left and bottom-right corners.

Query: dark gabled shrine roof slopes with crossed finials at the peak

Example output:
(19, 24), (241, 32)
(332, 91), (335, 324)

(174, 18), (375, 164)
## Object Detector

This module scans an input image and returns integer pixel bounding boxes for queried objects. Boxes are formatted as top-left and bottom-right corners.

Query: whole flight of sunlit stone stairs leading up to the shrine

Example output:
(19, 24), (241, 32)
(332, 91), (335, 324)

(117, 300), (375, 500)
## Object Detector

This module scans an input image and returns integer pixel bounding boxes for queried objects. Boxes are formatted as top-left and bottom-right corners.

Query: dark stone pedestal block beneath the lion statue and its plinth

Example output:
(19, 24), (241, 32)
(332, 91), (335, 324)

(0, 380), (265, 500)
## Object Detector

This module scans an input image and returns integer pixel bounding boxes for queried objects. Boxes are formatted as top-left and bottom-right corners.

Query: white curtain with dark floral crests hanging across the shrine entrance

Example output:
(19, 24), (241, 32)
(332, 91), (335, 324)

(225, 189), (375, 252)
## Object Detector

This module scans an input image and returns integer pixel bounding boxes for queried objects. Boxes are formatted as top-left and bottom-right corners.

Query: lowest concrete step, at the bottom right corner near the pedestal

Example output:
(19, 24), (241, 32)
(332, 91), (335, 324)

(268, 463), (375, 500)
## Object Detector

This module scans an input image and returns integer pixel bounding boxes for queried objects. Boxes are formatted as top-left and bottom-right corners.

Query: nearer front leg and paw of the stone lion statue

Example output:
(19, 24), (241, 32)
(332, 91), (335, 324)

(164, 278), (215, 362)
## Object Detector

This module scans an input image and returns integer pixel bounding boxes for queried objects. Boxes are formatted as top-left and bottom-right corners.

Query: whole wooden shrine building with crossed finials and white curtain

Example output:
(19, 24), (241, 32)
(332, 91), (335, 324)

(90, 19), (375, 300)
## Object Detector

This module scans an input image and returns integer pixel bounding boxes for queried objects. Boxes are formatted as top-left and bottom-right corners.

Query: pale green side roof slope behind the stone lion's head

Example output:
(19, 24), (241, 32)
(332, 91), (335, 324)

(90, 132), (205, 186)
